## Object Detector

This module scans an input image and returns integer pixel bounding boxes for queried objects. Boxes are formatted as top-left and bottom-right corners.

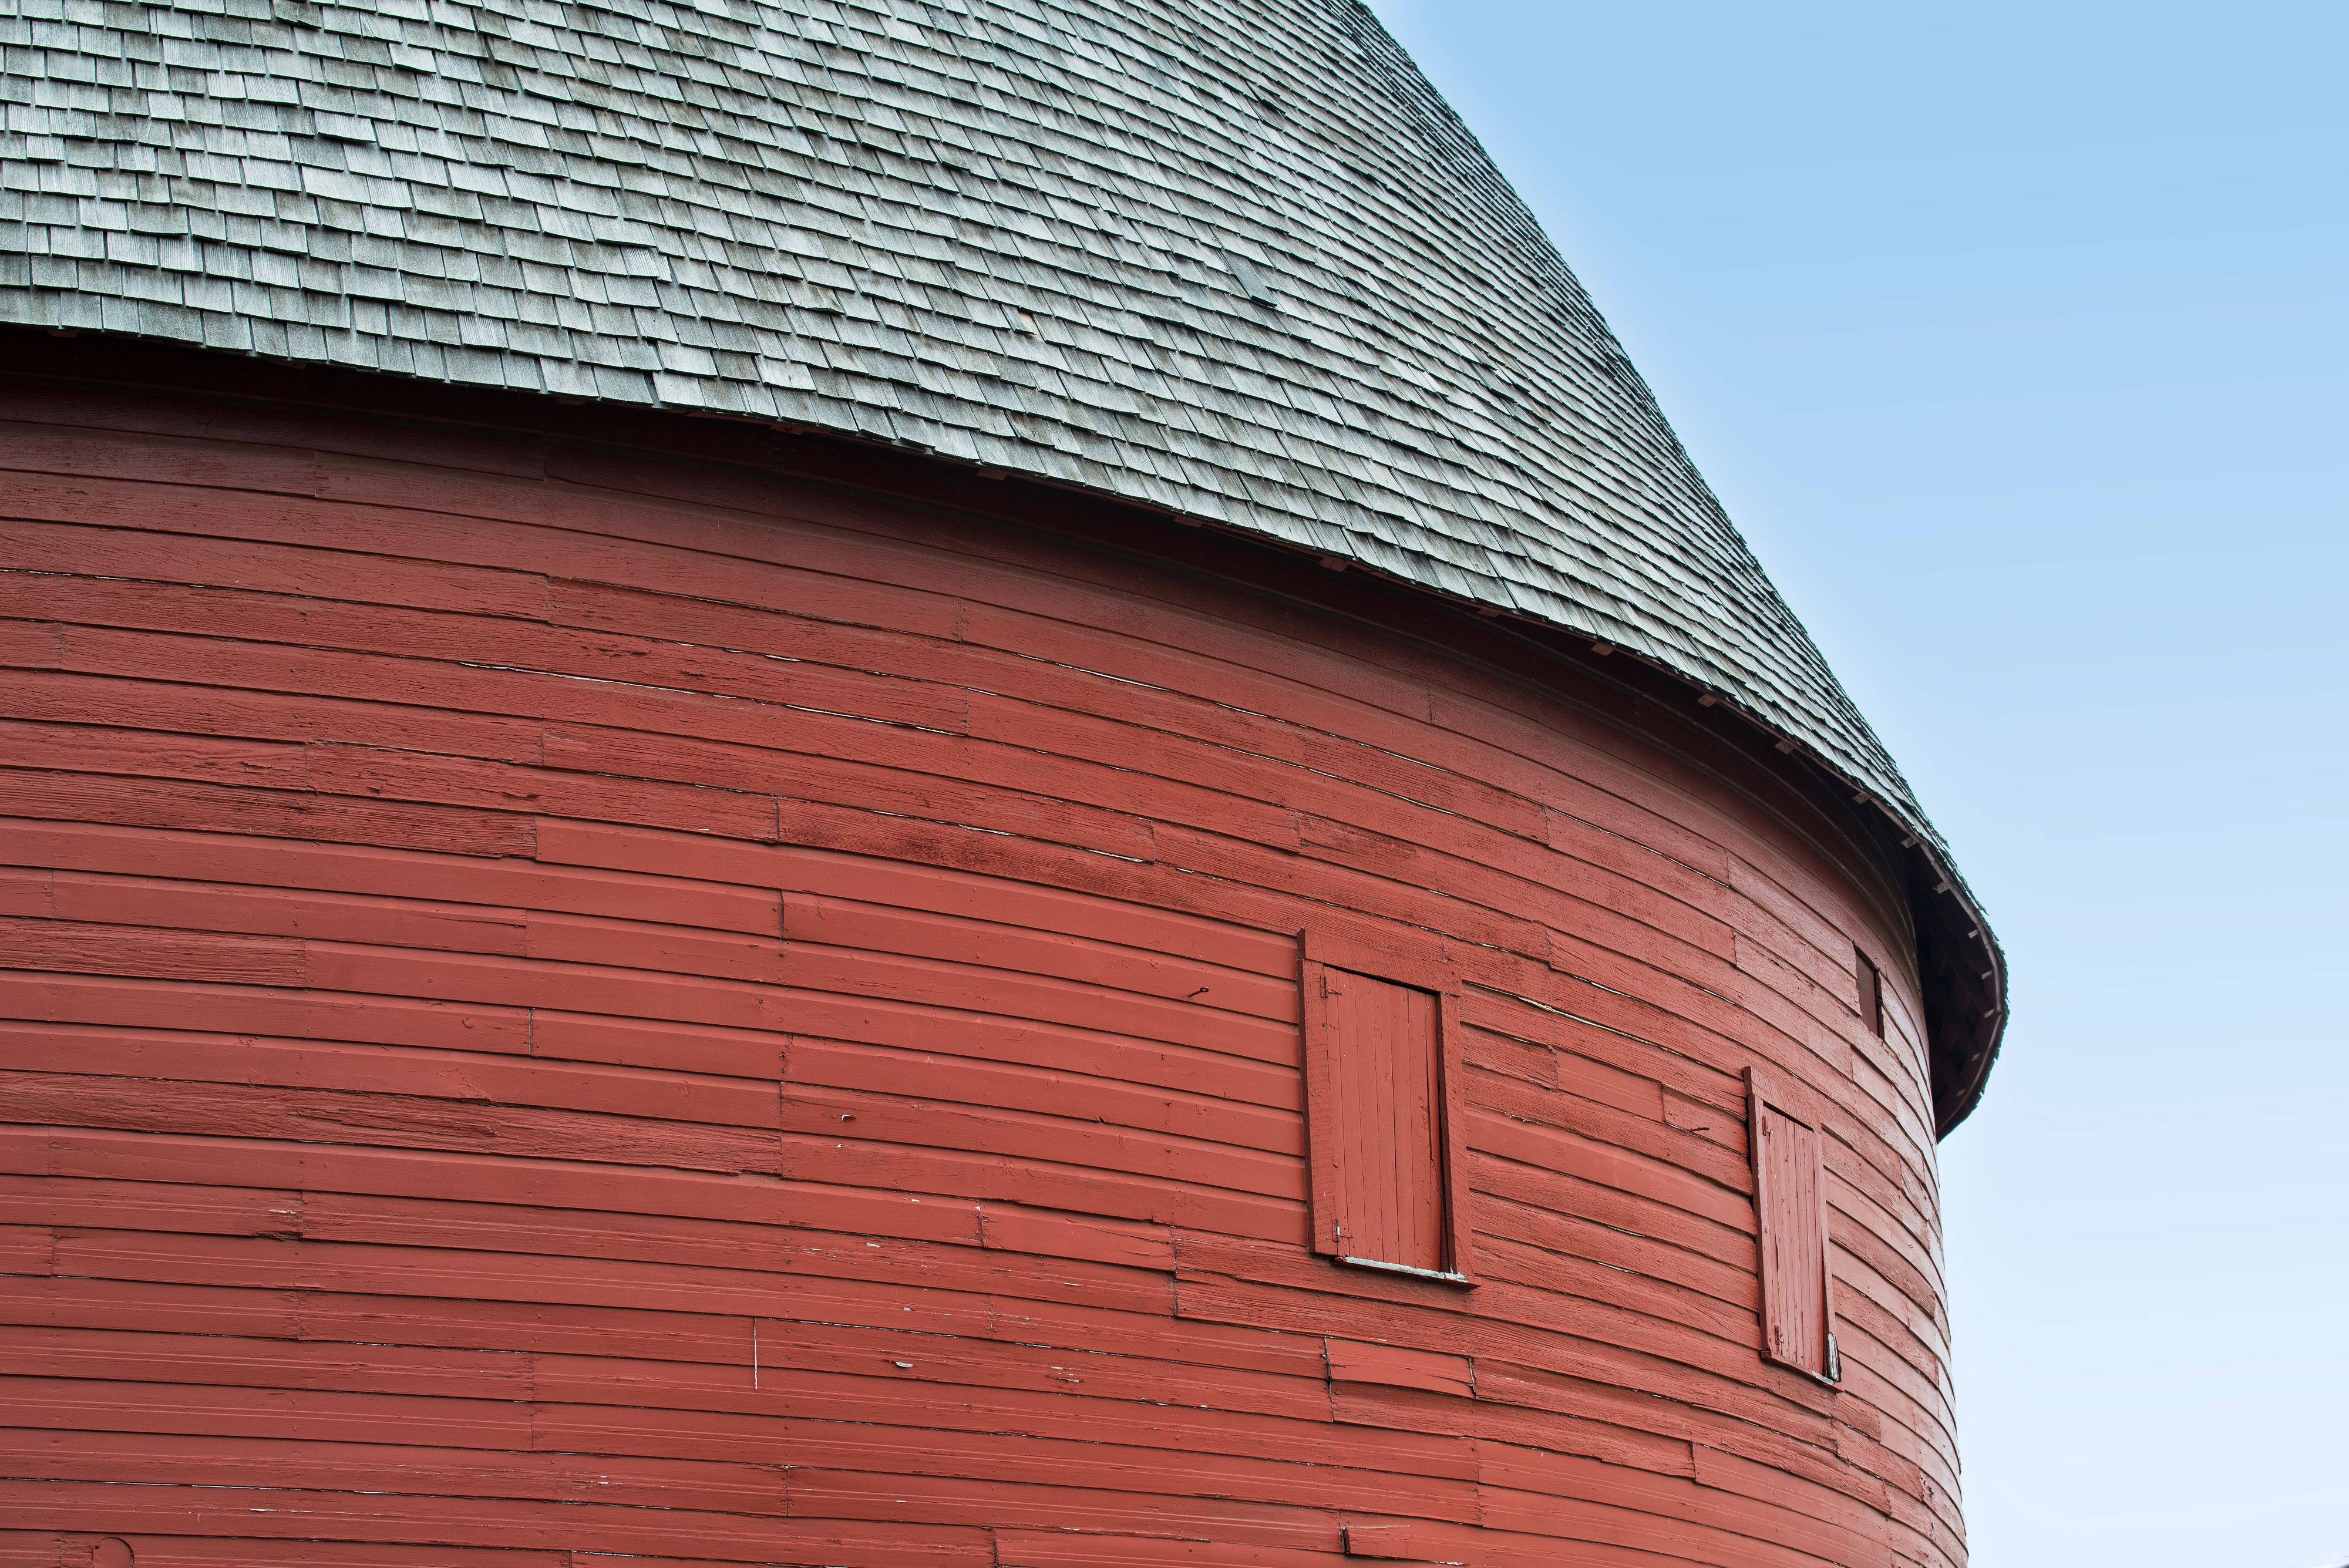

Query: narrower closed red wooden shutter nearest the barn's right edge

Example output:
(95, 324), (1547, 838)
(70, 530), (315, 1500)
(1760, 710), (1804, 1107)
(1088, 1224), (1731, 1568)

(1748, 1068), (1839, 1382)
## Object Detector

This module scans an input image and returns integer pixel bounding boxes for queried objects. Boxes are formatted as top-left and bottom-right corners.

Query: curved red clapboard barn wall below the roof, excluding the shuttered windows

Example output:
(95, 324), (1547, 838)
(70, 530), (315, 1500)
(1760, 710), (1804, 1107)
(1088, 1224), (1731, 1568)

(0, 382), (1964, 1568)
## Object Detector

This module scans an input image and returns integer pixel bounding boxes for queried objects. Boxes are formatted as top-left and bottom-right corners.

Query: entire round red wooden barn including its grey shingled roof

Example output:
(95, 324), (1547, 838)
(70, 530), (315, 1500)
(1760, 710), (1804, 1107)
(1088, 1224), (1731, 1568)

(0, 0), (2004, 1568)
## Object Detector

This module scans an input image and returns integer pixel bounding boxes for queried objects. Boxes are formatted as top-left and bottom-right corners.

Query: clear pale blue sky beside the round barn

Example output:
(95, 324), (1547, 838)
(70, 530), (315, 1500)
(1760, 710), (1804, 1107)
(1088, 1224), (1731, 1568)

(1374, 0), (2349, 1568)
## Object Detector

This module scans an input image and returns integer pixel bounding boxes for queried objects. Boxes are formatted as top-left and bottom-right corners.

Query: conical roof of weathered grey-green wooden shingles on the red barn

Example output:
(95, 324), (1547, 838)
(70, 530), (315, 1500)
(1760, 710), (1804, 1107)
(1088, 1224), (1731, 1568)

(0, 0), (1997, 1122)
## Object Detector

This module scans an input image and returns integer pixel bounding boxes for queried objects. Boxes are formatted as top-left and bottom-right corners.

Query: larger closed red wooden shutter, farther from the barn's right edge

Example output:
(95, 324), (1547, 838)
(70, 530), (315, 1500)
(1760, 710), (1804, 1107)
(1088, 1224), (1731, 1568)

(1304, 944), (1466, 1279)
